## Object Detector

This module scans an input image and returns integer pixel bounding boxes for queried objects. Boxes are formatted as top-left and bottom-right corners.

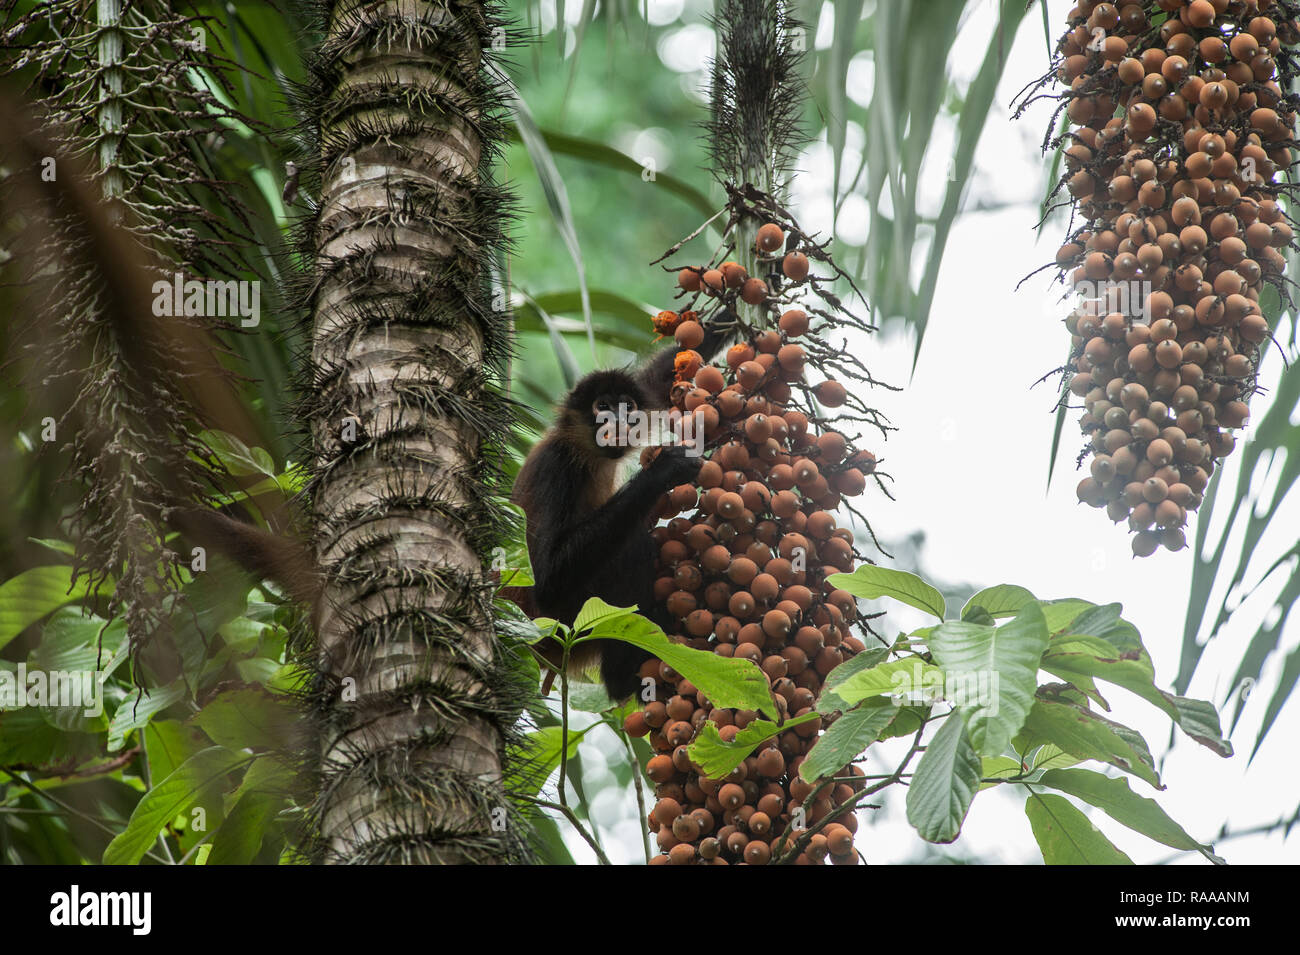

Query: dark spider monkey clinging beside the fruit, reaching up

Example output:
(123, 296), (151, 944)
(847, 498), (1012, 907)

(503, 322), (727, 699)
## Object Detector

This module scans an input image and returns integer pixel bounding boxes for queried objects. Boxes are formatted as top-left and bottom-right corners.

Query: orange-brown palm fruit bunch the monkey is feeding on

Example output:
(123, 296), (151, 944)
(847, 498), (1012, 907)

(627, 191), (888, 864)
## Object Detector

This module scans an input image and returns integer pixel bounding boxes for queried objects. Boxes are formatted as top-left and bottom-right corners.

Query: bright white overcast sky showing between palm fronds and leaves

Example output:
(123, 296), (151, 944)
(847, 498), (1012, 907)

(553, 0), (1300, 864)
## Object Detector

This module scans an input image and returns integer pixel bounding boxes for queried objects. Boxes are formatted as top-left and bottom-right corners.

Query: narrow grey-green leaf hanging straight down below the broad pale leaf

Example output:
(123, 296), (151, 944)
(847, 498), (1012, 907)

(907, 713), (980, 843)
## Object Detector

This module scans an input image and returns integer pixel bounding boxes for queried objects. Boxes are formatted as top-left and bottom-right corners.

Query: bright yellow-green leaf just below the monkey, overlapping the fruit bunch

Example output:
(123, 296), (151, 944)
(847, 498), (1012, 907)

(575, 598), (780, 719)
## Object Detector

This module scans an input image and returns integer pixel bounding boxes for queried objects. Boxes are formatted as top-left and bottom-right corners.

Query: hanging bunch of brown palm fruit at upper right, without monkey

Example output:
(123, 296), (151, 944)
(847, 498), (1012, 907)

(1022, 0), (1300, 557)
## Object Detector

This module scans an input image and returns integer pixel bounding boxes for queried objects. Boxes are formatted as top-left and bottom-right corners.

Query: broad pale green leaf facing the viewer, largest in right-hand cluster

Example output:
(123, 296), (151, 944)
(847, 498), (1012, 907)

(930, 602), (1048, 756)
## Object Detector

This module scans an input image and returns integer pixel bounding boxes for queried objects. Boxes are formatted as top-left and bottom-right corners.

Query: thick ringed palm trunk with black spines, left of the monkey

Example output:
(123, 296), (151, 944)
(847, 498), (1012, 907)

(306, 0), (521, 864)
